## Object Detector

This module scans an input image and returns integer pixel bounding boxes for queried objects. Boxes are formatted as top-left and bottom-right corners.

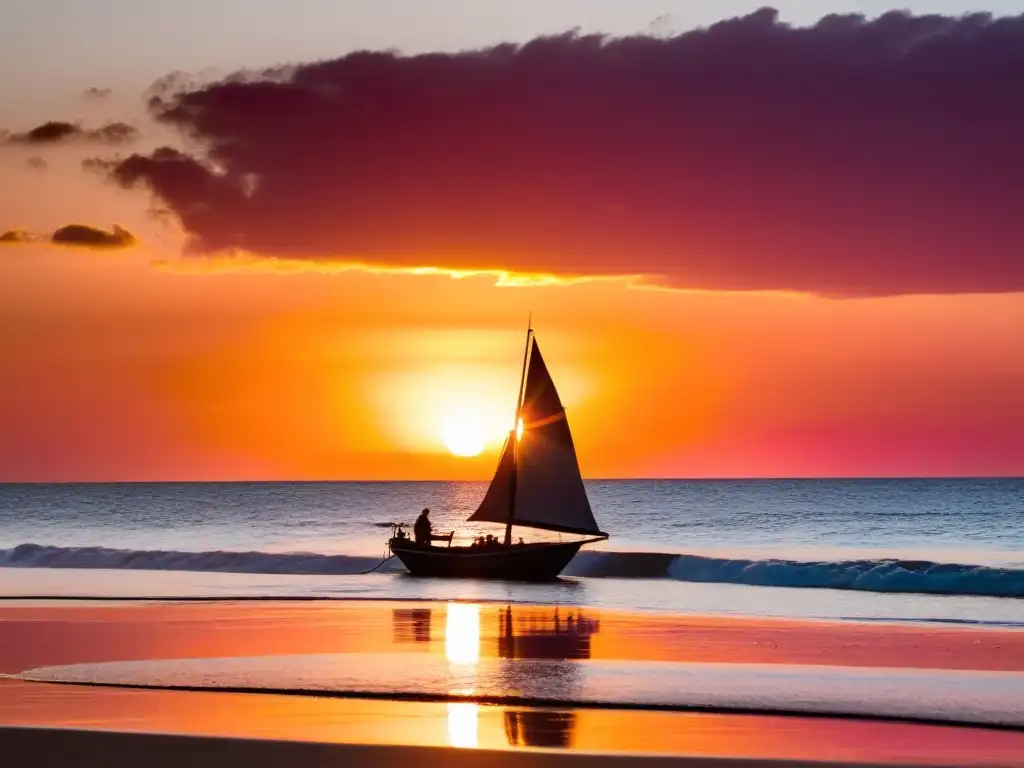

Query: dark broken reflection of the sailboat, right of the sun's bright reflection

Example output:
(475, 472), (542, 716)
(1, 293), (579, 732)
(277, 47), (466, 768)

(498, 606), (600, 748)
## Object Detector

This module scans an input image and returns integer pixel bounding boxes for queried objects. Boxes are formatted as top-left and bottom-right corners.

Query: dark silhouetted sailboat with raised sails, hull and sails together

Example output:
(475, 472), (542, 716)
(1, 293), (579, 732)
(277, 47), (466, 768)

(388, 326), (608, 581)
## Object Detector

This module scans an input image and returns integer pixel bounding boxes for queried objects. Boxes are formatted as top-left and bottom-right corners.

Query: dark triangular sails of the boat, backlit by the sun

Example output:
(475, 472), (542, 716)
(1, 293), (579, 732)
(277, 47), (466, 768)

(469, 338), (604, 536)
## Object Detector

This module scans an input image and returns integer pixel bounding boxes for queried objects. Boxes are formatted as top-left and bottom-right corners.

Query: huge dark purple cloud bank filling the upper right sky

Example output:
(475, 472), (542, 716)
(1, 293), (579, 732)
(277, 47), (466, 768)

(113, 9), (1024, 296)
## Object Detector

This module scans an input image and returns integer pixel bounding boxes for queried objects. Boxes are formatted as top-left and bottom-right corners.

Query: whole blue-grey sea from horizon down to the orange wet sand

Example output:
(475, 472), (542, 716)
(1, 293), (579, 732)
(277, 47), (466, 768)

(0, 478), (1024, 627)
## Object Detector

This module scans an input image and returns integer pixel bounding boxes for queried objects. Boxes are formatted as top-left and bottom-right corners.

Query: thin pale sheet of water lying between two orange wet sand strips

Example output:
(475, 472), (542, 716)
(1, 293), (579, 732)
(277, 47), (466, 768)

(18, 659), (1024, 729)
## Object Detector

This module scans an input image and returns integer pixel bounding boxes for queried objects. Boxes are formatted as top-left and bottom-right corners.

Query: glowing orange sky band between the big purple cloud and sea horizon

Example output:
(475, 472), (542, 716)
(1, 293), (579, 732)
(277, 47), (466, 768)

(0, 231), (1024, 481)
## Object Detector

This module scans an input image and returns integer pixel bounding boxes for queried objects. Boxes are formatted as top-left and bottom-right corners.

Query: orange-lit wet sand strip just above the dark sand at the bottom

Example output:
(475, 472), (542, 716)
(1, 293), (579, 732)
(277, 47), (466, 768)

(6, 683), (1024, 768)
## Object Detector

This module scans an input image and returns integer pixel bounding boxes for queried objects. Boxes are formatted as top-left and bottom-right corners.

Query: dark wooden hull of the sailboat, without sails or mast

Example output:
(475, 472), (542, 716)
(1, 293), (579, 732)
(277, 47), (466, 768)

(391, 540), (586, 582)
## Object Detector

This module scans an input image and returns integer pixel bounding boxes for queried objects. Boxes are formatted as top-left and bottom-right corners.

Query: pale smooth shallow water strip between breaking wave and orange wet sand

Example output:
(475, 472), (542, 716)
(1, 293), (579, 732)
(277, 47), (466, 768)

(0, 568), (1024, 629)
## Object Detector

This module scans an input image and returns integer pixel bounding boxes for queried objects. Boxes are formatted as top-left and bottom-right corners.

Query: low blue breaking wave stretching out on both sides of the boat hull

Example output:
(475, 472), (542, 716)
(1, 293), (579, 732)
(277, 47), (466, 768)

(0, 544), (1024, 597)
